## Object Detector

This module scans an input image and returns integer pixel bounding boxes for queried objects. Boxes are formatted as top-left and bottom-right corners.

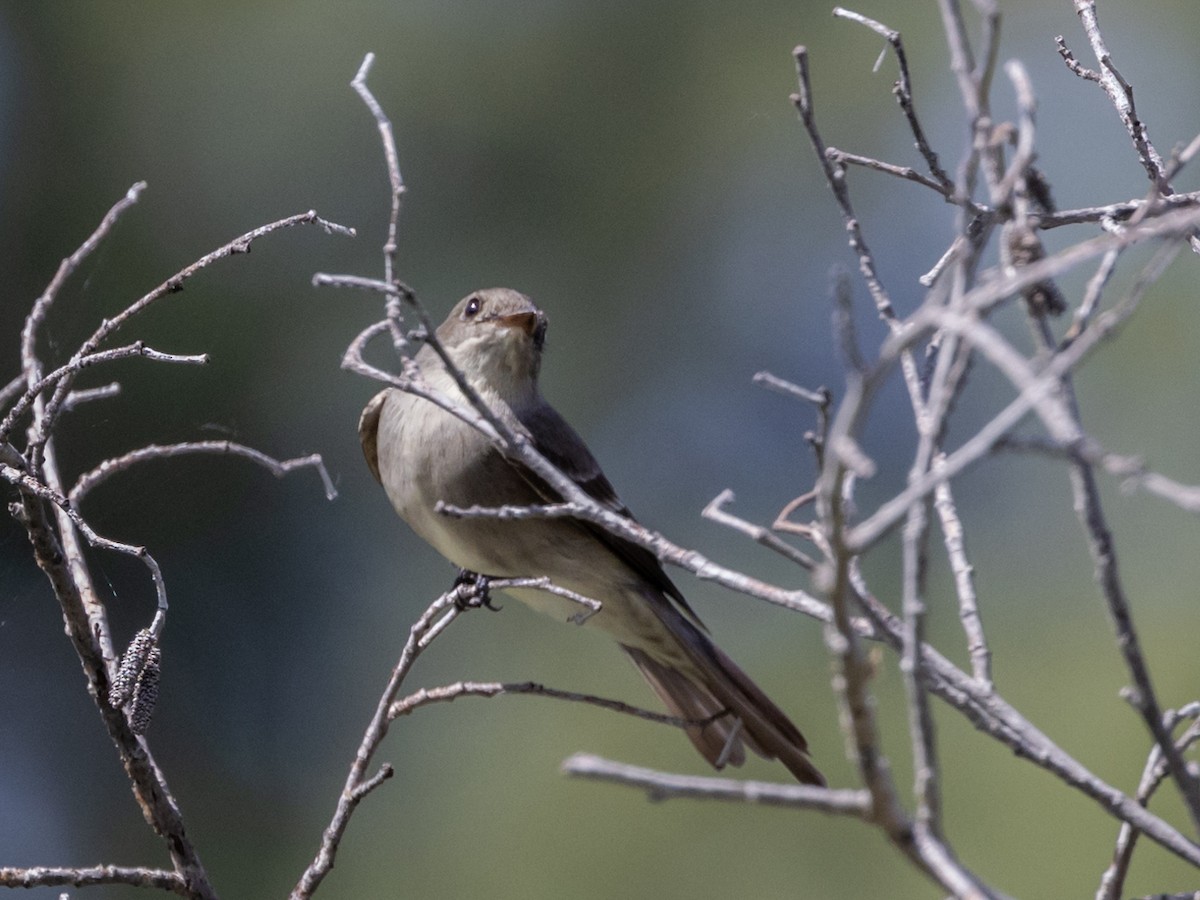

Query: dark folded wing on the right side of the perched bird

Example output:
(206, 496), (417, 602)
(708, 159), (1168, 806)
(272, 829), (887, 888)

(514, 401), (704, 629)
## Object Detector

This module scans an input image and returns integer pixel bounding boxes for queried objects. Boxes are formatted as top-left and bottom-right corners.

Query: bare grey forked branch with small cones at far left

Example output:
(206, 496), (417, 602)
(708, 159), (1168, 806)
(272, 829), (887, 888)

(0, 177), (352, 900)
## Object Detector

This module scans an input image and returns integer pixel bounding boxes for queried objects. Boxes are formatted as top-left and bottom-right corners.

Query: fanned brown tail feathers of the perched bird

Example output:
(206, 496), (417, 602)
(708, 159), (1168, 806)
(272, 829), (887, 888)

(622, 638), (826, 785)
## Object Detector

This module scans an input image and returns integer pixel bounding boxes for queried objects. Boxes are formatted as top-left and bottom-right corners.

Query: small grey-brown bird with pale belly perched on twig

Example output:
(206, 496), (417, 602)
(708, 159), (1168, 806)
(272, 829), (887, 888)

(359, 288), (826, 785)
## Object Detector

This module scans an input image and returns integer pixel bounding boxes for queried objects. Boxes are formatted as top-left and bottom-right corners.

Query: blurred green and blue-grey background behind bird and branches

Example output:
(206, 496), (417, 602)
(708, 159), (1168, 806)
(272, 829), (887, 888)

(0, 0), (1200, 900)
